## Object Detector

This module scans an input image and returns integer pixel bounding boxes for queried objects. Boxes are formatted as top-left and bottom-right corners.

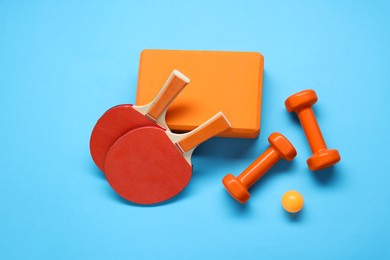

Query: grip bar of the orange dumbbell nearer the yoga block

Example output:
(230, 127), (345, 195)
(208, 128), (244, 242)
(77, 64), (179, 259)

(238, 147), (282, 189)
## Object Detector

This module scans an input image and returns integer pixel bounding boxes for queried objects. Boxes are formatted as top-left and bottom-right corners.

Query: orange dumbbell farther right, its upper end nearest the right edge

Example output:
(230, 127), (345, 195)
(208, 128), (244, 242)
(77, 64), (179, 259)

(284, 90), (340, 171)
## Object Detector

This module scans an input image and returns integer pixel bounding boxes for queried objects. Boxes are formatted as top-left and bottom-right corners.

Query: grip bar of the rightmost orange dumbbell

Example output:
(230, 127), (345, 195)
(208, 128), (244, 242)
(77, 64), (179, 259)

(297, 107), (327, 153)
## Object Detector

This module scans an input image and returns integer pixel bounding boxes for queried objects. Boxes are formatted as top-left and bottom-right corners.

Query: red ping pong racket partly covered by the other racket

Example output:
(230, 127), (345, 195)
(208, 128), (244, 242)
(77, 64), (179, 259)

(89, 70), (190, 171)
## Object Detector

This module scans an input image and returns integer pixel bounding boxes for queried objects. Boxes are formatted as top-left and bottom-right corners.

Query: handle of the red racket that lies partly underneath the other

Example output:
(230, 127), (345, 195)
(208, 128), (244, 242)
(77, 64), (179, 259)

(146, 70), (190, 121)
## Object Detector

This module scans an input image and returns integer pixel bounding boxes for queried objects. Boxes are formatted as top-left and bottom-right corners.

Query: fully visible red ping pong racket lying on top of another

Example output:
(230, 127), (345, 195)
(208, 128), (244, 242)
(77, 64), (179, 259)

(104, 112), (230, 204)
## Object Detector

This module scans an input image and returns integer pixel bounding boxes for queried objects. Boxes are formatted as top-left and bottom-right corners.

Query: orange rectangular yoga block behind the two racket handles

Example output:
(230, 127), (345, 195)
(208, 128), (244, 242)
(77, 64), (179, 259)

(136, 50), (264, 138)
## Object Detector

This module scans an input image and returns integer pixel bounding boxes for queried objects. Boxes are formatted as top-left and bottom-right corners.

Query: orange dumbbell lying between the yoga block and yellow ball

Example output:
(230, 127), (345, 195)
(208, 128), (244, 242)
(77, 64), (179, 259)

(222, 133), (297, 203)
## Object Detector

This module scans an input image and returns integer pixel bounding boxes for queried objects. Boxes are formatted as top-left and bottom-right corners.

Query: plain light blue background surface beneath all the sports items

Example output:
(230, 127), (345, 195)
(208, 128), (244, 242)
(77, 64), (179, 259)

(0, 0), (390, 259)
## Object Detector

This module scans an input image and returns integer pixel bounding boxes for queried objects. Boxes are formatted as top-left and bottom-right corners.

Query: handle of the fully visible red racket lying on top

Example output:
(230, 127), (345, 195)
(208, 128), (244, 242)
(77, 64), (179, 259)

(176, 112), (231, 153)
